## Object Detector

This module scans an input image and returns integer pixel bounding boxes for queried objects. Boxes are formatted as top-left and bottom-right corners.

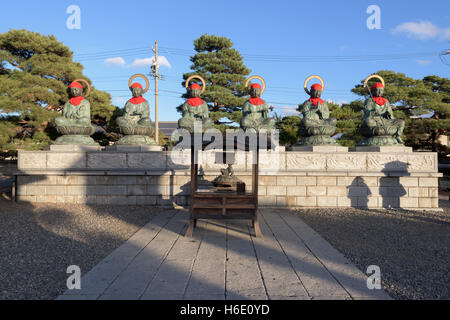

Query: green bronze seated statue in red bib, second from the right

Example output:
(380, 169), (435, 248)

(297, 76), (337, 146)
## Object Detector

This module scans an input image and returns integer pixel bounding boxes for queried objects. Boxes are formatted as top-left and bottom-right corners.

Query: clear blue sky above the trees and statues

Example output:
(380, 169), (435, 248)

(0, 0), (450, 121)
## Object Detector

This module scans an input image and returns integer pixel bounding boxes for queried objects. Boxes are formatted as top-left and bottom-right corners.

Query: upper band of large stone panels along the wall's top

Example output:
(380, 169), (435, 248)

(18, 150), (438, 176)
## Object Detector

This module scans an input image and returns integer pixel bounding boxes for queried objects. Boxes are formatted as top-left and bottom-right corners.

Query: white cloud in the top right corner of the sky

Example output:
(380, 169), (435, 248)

(392, 21), (450, 40)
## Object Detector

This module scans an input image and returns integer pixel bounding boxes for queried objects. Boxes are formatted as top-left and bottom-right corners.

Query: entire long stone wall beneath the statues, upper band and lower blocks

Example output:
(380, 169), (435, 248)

(17, 151), (440, 210)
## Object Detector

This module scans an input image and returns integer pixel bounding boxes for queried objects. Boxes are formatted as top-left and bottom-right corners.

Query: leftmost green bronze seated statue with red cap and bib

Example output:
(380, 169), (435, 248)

(54, 79), (97, 145)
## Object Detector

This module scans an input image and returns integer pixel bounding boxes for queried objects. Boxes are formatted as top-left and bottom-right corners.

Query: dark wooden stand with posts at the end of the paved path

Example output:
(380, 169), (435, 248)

(185, 134), (262, 237)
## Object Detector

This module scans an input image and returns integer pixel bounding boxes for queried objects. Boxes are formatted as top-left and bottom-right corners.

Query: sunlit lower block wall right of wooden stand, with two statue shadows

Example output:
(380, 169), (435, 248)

(258, 174), (439, 209)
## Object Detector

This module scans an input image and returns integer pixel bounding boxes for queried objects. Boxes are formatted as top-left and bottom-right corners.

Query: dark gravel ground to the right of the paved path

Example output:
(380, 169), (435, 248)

(296, 201), (450, 300)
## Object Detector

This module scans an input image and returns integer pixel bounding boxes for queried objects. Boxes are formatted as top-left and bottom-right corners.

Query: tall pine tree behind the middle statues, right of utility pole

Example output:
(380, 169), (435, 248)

(178, 34), (250, 131)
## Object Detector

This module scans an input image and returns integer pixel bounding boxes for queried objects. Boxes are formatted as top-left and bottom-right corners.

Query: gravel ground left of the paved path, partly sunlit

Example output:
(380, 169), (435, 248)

(0, 199), (160, 300)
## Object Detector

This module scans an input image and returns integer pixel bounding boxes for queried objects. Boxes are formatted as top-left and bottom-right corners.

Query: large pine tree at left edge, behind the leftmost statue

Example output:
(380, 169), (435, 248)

(0, 30), (116, 149)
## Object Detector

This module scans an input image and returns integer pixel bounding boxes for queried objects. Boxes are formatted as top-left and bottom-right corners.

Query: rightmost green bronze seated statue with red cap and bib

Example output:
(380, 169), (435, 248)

(358, 75), (405, 146)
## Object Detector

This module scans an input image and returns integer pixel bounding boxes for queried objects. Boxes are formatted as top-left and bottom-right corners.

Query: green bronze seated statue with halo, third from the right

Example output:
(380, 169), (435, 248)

(241, 76), (275, 132)
